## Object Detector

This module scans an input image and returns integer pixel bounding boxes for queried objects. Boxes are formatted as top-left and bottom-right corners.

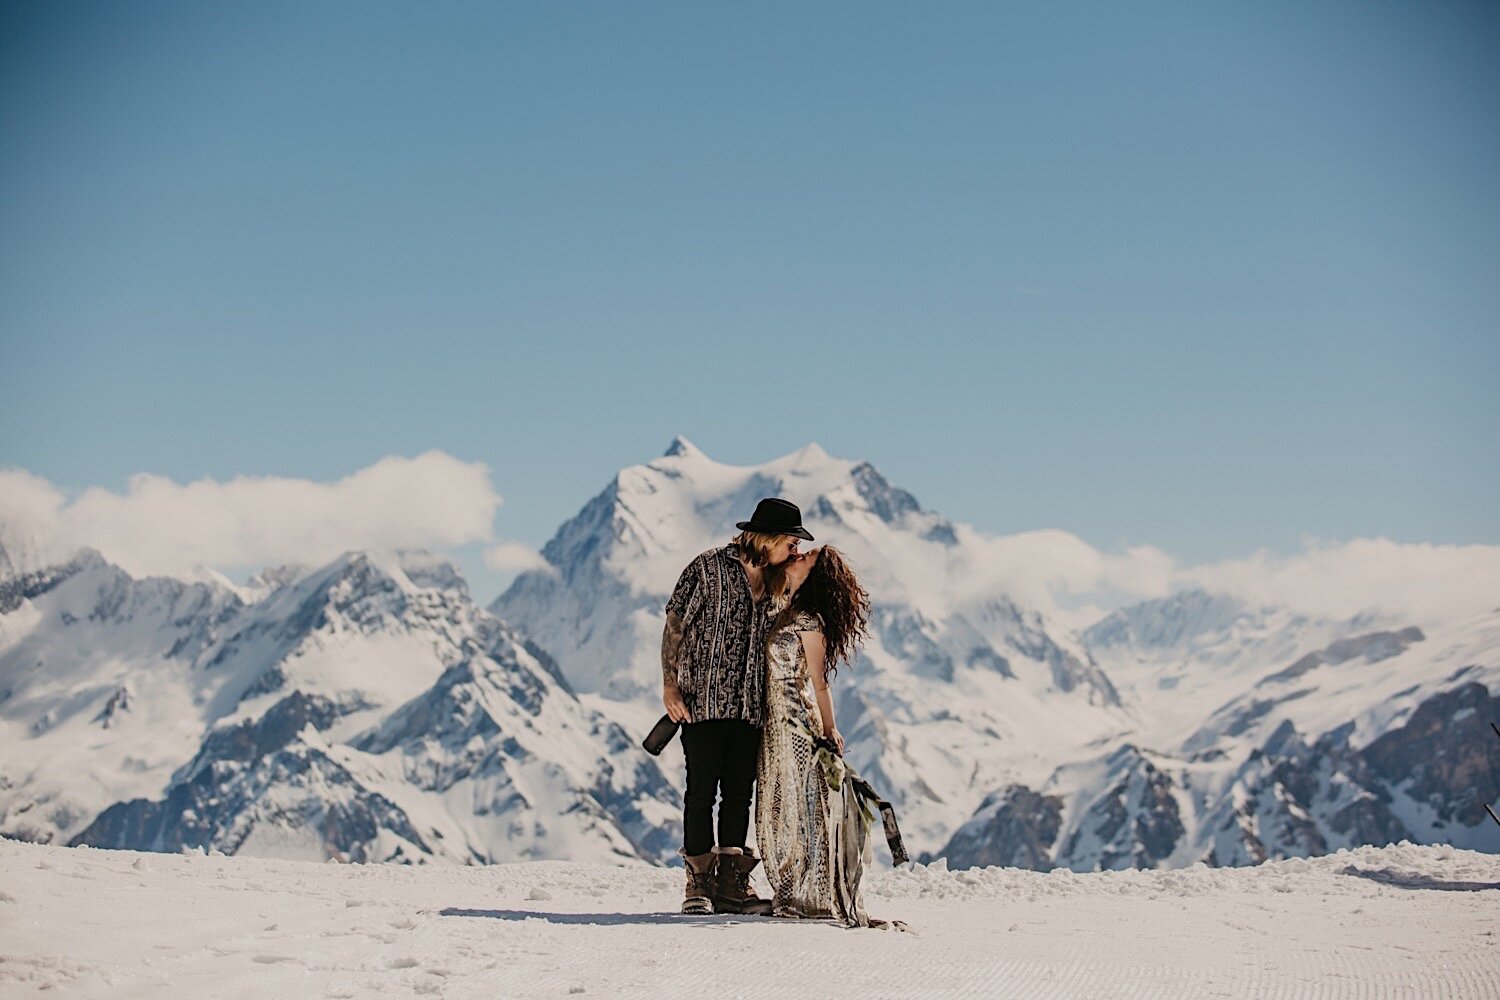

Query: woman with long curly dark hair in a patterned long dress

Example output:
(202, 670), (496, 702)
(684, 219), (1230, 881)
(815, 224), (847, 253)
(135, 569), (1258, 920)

(756, 546), (884, 927)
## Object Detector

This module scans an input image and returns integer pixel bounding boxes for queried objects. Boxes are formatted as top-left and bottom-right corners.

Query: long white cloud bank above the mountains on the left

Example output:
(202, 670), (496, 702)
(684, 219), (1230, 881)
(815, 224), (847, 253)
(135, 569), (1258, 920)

(0, 451), (501, 576)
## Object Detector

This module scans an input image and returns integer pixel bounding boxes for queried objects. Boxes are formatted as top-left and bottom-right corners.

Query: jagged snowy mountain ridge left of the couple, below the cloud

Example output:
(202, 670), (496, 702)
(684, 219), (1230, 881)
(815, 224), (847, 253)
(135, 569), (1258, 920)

(0, 542), (680, 862)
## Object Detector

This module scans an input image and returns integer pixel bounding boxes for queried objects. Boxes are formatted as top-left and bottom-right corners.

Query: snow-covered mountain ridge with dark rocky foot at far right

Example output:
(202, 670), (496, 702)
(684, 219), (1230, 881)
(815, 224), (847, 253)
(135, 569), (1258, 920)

(935, 592), (1500, 871)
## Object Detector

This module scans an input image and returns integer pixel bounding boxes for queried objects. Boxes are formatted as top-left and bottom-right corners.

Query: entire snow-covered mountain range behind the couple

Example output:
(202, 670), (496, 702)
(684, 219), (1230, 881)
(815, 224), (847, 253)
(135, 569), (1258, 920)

(0, 438), (1500, 870)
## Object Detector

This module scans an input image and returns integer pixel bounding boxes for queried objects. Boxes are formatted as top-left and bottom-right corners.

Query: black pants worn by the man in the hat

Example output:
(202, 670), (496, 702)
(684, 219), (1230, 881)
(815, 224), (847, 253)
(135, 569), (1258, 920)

(683, 718), (761, 856)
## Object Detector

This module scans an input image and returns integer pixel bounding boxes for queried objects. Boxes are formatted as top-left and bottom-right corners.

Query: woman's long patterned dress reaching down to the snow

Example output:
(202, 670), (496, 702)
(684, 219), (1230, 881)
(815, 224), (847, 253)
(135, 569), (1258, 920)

(755, 612), (875, 927)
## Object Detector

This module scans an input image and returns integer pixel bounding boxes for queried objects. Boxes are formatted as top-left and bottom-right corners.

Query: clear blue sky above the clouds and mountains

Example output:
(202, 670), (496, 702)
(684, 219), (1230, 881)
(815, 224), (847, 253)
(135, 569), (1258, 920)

(0, 3), (1500, 590)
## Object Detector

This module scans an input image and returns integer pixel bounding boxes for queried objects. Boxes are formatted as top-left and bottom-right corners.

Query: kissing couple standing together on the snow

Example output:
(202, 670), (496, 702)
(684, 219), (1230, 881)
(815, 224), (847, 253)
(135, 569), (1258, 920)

(662, 498), (906, 930)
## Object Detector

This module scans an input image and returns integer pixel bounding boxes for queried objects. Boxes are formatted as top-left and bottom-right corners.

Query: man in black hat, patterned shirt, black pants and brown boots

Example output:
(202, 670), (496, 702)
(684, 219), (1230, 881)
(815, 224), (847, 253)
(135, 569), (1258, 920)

(662, 498), (813, 913)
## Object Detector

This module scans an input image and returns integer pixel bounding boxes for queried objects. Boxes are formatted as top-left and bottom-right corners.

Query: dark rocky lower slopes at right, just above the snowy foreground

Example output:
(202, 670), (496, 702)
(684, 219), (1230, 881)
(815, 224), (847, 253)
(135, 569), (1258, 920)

(941, 682), (1500, 870)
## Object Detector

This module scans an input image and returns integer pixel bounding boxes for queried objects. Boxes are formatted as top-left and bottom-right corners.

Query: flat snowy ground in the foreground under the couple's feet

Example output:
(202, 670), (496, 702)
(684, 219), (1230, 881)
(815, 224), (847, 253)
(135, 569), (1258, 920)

(0, 840), (1500, 1000)
